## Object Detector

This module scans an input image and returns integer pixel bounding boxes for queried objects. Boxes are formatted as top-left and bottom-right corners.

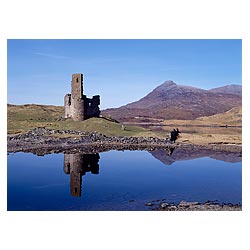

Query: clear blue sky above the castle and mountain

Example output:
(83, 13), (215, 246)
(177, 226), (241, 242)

(7, 39), (242, 109)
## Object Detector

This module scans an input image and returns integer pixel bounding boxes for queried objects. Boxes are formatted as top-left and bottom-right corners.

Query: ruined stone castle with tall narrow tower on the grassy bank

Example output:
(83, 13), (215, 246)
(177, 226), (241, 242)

(64, 74), (100, 121)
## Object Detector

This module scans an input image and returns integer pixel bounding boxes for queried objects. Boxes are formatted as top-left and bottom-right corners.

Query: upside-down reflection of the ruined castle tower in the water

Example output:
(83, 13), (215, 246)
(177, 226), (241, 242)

(64, 153), (100, 197)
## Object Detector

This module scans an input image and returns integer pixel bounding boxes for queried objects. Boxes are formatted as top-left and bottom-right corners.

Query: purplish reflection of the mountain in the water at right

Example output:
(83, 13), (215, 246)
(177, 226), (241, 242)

(150, 148), (242, 165)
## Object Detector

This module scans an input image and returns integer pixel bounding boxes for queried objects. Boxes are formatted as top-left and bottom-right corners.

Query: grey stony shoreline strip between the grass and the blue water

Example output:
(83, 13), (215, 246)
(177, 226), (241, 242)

(7, 128), (241, 155)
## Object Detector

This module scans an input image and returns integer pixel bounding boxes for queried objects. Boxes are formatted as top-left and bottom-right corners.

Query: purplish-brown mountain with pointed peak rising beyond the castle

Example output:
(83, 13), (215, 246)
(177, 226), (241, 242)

(102, 81), (241, 121)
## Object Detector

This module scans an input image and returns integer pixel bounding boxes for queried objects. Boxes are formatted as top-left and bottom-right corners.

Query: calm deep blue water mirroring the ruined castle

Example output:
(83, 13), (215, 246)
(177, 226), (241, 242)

(8, 151), (242, 211)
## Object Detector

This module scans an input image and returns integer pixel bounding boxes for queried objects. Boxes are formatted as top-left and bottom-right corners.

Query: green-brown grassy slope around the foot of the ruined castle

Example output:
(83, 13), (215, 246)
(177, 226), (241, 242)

(7, 104), (160, 137)
